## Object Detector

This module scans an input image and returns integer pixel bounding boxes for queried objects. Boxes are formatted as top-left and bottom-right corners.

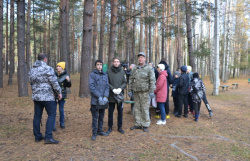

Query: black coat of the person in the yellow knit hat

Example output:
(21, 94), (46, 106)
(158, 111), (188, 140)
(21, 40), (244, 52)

(55, 70), (71, 98)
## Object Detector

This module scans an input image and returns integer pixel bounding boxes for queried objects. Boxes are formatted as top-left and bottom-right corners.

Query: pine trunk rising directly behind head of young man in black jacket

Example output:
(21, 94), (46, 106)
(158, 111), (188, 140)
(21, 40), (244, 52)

(108, 0), (118, 67)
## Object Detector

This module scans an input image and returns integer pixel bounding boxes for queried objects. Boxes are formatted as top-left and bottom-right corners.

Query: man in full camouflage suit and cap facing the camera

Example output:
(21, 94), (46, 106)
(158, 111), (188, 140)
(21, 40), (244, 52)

(128, 52), (155, 132)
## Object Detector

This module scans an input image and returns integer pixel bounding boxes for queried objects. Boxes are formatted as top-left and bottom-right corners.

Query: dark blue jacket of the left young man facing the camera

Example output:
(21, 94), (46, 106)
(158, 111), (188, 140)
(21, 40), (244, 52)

(89, 69), (109, 105)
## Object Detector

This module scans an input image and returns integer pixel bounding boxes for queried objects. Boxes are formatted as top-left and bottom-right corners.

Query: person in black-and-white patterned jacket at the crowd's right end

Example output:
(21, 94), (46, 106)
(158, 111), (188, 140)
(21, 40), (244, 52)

(189, 73), (206, 121)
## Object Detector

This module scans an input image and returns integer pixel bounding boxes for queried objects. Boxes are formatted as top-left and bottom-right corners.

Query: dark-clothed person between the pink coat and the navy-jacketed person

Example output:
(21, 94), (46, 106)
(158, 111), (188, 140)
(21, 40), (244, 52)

(170, 70), (181, 116)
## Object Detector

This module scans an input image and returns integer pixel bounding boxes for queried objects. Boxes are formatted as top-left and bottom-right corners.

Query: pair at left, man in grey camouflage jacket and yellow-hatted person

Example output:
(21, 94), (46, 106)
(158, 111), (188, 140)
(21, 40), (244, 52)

(29, 53), (71, 144)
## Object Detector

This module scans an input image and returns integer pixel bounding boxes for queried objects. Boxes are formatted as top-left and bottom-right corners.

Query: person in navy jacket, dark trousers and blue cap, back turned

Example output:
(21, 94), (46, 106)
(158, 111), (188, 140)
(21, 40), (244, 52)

(177, 66), (189, 118)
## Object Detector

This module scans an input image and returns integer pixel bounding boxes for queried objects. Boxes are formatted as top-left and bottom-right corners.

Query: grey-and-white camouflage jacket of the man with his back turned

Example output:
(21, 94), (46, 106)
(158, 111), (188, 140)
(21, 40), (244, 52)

(29, 60), (62, 101)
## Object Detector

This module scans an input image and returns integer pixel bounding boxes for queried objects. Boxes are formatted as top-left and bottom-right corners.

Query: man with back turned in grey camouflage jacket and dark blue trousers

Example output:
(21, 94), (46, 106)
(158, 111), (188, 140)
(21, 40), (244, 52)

(29, 53), (62, 144)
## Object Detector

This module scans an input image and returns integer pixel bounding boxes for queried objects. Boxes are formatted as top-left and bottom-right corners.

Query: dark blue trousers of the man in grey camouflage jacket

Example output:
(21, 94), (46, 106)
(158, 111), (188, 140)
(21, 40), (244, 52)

(33, 101), (56, 140)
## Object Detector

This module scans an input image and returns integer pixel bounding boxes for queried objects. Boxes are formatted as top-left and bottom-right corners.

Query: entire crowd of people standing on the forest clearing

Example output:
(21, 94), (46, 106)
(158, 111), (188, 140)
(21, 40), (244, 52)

(29, 52), (213, 144)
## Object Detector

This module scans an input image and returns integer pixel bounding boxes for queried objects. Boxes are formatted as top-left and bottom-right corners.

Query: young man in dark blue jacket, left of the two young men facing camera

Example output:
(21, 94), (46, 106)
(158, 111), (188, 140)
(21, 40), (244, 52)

(89, 60), (109, 141)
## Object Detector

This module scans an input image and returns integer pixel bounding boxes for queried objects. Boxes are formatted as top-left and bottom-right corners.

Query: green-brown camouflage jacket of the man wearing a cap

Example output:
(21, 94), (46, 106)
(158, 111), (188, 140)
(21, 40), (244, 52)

(129, 64), (155, 92)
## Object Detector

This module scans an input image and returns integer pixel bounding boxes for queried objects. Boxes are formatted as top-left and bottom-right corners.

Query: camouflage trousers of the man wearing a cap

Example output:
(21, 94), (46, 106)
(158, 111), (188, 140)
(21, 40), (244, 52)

(134, 92), (150, 127)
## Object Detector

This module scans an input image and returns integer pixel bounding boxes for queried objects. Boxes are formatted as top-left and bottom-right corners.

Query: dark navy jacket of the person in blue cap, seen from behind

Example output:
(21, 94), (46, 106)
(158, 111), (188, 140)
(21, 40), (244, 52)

(178, 73), (189, 95)
